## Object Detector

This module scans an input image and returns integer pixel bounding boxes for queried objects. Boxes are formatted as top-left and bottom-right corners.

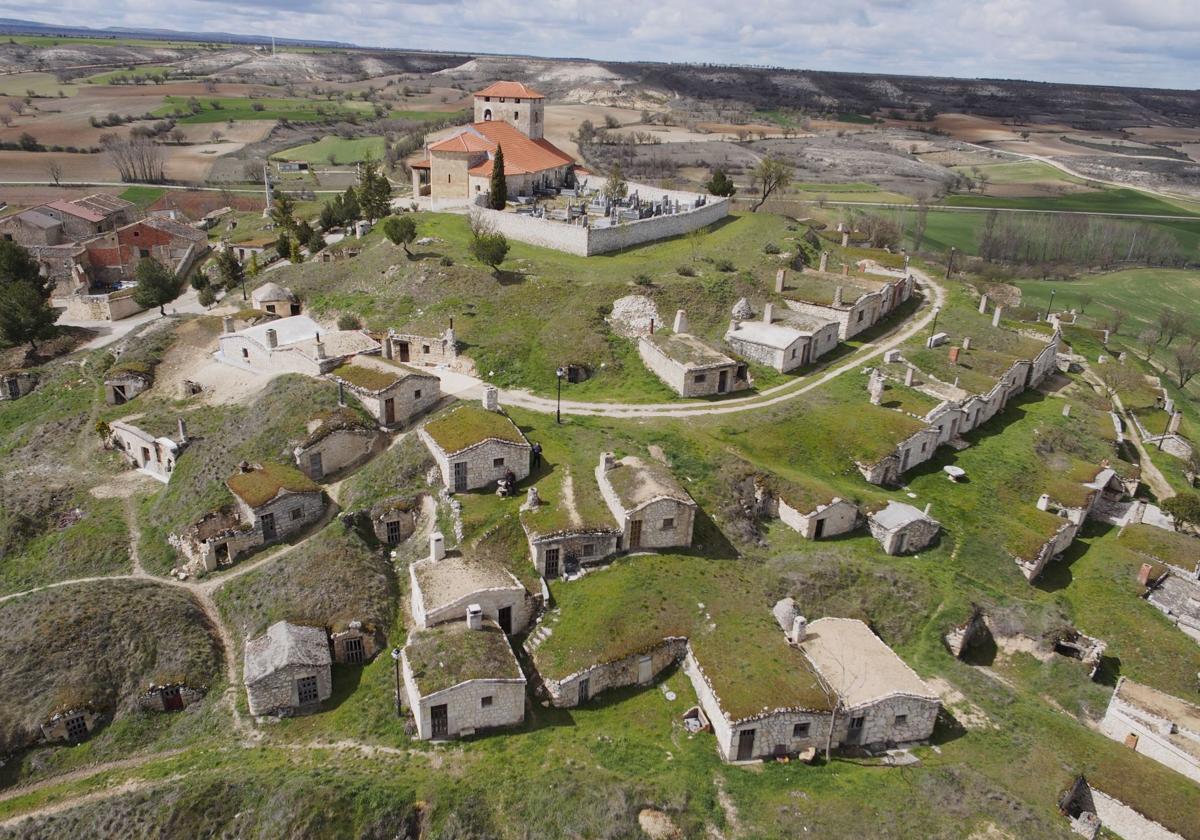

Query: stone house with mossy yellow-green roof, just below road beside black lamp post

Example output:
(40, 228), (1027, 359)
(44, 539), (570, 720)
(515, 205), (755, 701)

(418, 398), (533, 493)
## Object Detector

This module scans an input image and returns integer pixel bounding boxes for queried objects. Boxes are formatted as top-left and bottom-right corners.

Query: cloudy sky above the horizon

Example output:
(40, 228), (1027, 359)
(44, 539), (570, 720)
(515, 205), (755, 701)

(9, 0), (1200, 88)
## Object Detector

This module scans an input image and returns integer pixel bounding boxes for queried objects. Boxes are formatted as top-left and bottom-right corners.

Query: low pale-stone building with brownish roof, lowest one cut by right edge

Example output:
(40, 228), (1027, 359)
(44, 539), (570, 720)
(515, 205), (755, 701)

(1100, 677), (1200, 782)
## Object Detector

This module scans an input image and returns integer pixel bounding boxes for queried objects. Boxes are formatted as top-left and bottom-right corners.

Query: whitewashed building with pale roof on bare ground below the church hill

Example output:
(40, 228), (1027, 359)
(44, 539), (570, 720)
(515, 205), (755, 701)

(214, 316), (379, 377)
